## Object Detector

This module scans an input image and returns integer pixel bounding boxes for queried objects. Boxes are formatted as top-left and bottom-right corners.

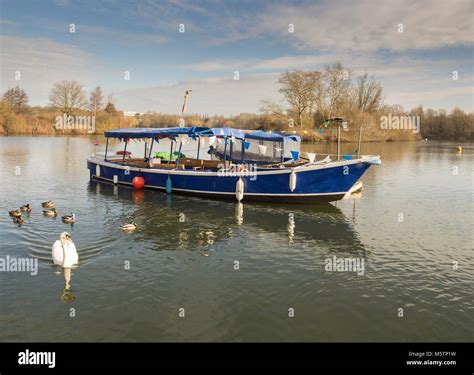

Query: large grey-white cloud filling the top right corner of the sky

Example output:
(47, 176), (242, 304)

(244, 0), (473, 51)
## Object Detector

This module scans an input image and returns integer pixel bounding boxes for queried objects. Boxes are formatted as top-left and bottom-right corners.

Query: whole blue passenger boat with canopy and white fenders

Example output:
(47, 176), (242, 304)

(87, 127), (381, 204)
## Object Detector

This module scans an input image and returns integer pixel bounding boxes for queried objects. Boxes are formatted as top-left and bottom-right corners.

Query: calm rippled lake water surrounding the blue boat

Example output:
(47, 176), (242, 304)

(0, 137), (474, 341)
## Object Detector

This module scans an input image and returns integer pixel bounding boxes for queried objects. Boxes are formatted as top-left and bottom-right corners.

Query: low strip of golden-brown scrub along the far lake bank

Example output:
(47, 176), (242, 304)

(0, 101), (474, 142)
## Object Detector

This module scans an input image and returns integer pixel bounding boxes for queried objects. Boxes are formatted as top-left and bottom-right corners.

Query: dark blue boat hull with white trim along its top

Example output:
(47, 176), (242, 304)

(87, 159), (370, 204)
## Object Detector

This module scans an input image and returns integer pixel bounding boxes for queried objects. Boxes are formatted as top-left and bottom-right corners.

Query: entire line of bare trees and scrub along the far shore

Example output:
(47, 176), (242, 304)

(0, 70), (474, 141)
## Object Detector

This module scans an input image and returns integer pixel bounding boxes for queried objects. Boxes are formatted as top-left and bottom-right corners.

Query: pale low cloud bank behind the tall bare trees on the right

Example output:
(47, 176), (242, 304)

(117, 47), (473, 115)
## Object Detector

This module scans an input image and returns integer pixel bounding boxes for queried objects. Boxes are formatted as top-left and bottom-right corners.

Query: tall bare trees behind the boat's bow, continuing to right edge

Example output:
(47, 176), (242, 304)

(260, 63), (474, 140)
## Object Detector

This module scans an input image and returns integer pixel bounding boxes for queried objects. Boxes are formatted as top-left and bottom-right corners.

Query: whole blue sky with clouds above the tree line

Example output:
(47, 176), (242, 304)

(0, 0), (474, 115)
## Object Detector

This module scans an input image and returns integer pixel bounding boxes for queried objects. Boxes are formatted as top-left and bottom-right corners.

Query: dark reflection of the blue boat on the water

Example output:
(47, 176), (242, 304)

(89, 181), (364, 252)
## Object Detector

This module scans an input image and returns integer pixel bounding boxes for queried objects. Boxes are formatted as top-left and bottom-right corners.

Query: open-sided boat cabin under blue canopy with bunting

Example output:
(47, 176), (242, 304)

(104, 127), (304, 171)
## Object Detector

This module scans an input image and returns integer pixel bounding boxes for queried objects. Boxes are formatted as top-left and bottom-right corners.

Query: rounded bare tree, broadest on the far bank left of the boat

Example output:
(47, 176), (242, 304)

(49, 81), (87, 116)
